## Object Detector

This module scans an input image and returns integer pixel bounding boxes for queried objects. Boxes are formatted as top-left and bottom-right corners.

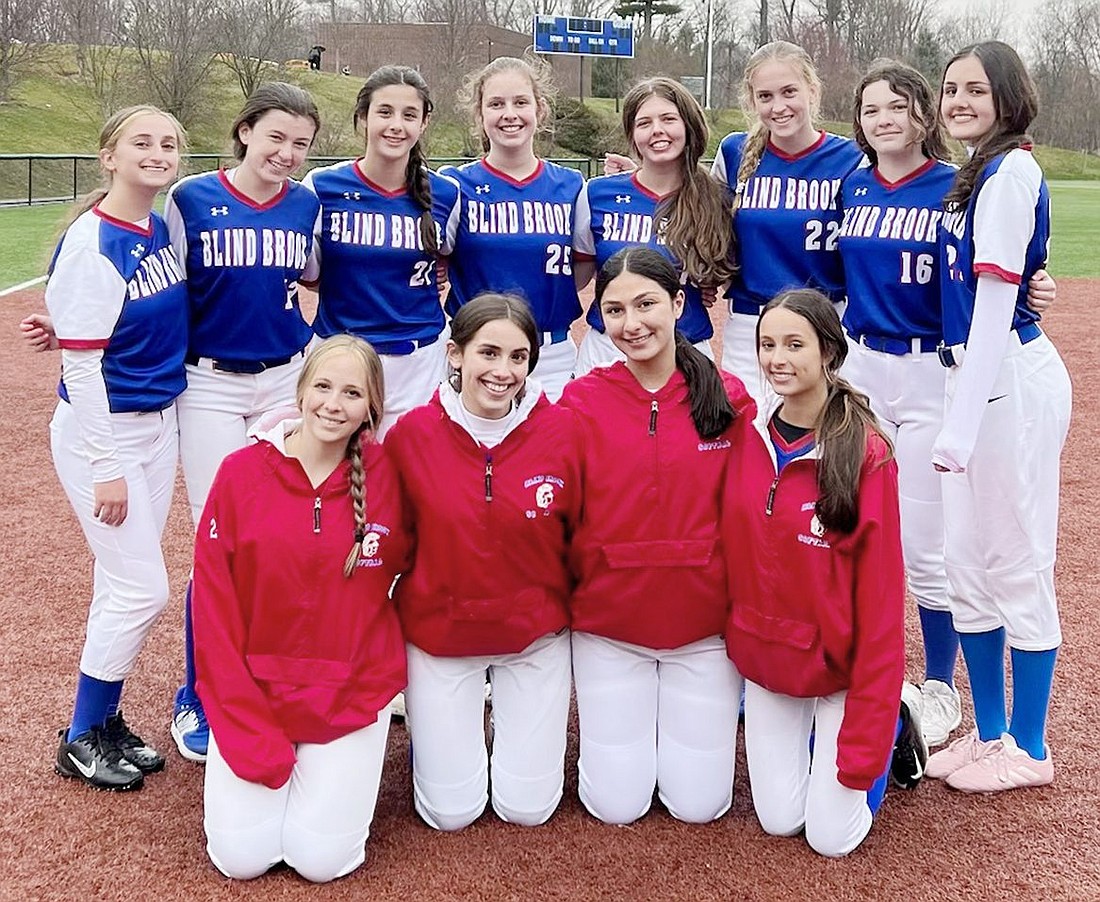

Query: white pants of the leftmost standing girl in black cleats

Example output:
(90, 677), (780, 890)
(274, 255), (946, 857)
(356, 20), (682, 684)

(50, 402), (179, 682)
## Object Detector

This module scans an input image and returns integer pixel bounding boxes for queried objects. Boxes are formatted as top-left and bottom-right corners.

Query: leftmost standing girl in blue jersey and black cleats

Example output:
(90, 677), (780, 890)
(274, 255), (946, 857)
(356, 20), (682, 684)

(46, 106), (187, 790)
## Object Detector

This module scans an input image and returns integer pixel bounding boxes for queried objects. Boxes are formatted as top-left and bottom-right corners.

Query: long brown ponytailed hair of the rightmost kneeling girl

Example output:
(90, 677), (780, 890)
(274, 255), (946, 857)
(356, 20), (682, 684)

(757, 288), (893, 532)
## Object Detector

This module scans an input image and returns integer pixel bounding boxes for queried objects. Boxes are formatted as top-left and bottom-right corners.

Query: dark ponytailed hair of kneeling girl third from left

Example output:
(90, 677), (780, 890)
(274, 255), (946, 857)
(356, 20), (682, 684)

(596, 248), (737, 440)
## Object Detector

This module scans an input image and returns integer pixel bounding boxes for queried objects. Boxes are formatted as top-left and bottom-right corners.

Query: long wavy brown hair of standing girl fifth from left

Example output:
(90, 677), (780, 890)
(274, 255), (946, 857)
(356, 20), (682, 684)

(623, 76), (734, 285)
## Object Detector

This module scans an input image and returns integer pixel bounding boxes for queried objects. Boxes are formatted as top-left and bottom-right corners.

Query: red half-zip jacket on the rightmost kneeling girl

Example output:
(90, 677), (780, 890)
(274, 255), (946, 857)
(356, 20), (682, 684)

(722, 417), (905, 790)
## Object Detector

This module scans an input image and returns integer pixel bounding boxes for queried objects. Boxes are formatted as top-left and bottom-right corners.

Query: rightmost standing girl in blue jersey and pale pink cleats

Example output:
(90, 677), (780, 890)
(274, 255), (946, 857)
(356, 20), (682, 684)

(927, 41), (1071, 792)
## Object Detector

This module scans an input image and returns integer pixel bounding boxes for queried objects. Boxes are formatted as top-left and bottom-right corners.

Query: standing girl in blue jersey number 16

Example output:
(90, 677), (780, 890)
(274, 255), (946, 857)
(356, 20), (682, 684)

(839, 62), (1053, 746)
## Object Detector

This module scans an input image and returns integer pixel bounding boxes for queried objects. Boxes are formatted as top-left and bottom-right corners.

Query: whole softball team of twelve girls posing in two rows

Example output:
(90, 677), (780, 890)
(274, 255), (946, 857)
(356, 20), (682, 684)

(21, 42), (1071, 882)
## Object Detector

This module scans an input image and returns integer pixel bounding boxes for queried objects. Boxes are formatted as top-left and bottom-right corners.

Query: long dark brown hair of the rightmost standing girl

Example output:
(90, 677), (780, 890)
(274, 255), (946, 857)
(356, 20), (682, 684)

(939, 41), (1038, 210)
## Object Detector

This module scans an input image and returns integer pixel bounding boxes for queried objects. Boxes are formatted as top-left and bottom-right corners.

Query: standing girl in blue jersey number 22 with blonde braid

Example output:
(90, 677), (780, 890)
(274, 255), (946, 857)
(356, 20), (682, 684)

(712, 41), (862, 400)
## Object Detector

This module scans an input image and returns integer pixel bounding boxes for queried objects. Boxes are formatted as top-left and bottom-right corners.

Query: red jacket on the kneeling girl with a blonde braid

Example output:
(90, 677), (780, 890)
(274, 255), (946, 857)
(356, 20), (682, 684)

(191, 424), (409, 789)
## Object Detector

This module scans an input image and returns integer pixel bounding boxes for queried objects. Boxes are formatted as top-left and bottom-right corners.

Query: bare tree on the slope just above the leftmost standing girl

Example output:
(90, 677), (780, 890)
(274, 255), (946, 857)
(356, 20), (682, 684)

(130, 0), (218, 125)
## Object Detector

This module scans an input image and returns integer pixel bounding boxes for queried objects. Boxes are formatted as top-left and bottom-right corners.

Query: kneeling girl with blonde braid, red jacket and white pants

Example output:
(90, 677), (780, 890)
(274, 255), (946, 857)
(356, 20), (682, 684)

(193, 336), (408, 882)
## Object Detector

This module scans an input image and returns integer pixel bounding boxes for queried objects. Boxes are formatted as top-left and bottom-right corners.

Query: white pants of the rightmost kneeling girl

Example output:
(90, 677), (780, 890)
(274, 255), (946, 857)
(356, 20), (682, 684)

(745, 680), (887, 858)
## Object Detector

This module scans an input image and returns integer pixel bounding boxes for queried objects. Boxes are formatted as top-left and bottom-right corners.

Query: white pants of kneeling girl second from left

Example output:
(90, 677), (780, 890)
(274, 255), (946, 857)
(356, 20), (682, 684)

(405, 630), (570, 831)
